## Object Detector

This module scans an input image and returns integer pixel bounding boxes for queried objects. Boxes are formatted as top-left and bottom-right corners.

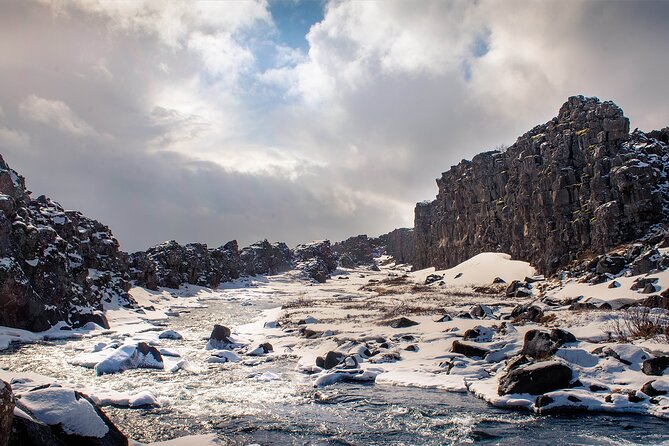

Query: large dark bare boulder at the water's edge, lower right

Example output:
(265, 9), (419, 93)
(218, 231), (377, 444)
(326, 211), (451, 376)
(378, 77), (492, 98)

(497, 361), (572, 395)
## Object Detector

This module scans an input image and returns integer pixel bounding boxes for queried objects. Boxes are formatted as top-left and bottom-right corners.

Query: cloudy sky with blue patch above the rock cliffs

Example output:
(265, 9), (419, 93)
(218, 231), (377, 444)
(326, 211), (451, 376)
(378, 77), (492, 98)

(0, 0), (669, 252)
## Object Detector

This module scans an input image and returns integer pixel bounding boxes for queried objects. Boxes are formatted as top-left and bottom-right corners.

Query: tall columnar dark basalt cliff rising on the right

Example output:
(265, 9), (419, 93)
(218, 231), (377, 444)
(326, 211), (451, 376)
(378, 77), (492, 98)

(414, 96), (669, 273)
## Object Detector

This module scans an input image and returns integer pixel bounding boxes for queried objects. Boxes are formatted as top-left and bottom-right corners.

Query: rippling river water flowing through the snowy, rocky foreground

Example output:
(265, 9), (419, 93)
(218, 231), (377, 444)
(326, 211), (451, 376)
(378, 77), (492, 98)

(0, 289), (669, 445)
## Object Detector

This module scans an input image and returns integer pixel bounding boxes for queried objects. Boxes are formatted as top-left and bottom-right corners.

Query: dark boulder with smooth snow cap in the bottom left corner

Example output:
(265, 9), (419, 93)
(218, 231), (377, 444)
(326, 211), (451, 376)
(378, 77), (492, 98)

(17, 387), (128, 446)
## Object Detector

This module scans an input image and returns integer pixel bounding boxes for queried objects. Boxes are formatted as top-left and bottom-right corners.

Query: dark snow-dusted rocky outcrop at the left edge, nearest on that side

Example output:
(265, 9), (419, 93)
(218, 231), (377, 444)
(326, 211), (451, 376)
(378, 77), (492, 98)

(0, 157), (133, 331)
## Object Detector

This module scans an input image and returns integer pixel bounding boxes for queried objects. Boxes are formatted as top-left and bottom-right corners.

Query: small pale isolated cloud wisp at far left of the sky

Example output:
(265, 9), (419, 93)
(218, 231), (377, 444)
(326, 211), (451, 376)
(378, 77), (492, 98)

(19, 95), (98, 136)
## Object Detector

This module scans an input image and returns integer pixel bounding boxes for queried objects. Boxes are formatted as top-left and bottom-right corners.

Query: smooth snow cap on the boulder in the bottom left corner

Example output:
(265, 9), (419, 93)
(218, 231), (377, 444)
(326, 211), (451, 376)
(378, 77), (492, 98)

(20, 387), (109, 438)
